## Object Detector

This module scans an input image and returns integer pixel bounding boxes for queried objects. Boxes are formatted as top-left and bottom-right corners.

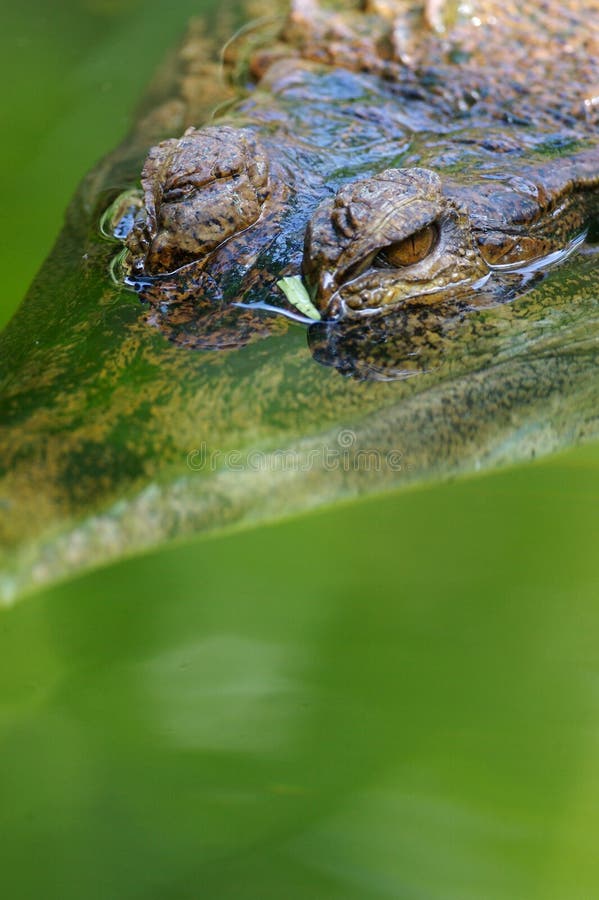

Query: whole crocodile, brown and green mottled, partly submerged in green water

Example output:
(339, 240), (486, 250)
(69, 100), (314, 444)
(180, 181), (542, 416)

(0, 0), (599, 603)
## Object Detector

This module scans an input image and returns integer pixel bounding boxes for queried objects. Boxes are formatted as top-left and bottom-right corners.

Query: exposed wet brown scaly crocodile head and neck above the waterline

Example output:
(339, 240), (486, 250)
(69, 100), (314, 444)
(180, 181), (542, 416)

(115, 0), (599, 372)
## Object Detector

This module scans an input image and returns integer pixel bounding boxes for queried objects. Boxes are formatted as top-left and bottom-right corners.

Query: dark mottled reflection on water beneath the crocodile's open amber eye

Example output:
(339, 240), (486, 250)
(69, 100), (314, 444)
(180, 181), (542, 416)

(308, 247), (596, 381)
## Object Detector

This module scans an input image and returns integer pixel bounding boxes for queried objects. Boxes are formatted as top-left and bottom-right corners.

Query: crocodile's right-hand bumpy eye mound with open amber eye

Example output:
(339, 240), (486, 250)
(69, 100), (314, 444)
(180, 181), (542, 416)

(303, 168), (489, 318)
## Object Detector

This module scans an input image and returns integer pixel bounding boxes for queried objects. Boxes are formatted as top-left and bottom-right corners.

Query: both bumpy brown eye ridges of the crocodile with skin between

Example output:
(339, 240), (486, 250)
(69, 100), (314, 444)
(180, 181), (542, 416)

(115, 126), (581, 340)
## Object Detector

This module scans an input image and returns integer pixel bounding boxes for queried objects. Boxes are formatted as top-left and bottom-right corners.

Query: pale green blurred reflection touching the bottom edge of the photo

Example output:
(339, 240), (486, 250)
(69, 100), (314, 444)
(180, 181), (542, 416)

(292, 780), (535, 900)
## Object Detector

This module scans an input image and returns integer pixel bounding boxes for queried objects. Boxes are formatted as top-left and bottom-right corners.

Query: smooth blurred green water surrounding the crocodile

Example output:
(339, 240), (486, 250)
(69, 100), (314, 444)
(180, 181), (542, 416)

(0, 0), (599, 900)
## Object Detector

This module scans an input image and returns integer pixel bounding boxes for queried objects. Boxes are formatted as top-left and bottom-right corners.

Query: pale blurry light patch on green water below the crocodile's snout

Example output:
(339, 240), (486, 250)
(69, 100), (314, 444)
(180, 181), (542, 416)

(137, 634), (304, 753)
